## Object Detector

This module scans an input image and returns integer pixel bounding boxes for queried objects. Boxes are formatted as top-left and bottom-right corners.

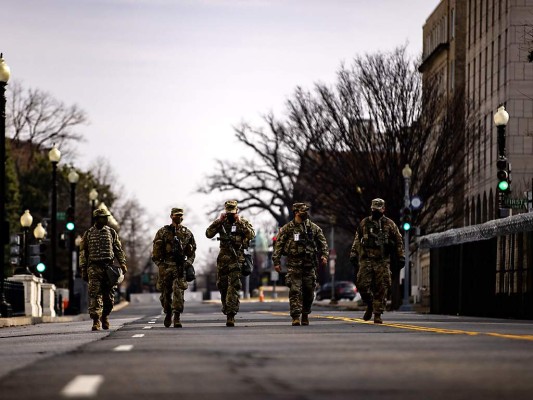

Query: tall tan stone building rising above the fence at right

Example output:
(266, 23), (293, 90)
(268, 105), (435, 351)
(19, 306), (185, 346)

(420, 0), (533, 225)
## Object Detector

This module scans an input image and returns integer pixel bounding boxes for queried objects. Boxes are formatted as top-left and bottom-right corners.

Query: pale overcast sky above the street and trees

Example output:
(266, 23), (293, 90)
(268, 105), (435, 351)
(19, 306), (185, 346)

(0, 0), (439, 266)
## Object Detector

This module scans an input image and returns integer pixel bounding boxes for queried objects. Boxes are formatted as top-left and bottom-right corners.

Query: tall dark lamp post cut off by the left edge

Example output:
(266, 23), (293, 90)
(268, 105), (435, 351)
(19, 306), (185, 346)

(0, 53), (13, 317)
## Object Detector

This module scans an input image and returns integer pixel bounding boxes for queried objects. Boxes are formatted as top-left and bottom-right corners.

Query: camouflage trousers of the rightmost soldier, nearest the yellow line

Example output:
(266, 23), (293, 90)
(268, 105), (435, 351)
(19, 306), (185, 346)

(357, 259), (392, 314)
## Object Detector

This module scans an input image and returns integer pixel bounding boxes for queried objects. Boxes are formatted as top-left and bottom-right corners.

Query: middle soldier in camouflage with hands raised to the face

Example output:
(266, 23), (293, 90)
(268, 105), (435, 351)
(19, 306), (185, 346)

(205, 200), (255, 326)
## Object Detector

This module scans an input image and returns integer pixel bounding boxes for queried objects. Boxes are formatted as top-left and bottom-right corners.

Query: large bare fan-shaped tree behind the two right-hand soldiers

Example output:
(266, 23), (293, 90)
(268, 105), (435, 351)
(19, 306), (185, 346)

(288, 48), (470, 234)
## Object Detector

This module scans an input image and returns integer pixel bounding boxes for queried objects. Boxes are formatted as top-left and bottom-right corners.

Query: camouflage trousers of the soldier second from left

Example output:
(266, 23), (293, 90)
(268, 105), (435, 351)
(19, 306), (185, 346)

(156, 264), (188, 313)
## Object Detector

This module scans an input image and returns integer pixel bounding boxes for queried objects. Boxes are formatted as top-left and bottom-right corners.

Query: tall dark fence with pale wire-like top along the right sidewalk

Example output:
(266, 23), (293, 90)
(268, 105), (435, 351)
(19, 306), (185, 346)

(419, 213), (533, 319)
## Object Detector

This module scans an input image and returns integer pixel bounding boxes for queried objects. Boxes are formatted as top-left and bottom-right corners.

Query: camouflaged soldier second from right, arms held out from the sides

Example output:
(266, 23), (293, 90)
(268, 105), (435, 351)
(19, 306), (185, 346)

(272, 203), (328, 326)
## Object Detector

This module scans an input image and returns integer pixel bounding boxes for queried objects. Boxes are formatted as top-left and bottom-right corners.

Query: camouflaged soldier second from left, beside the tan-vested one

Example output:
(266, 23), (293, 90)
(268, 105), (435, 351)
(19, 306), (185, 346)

(152, 208), (196, 328)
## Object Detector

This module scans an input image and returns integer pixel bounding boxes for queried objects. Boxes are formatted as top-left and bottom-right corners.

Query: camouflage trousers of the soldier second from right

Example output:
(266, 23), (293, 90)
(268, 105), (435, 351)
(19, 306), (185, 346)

(285, 265), (316, 318)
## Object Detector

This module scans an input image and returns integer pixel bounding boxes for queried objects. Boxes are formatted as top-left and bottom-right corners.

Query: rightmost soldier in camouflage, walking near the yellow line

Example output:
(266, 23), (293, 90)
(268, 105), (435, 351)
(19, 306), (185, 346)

(350, 199), (405, 324)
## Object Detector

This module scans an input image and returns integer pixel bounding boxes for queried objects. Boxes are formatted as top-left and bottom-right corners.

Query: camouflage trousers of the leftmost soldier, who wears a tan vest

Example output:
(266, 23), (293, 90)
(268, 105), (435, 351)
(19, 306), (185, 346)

(87, 263), (117, 319)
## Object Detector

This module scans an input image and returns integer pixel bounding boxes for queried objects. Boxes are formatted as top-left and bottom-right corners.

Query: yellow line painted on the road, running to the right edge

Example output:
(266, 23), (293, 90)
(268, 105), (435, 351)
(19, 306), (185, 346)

(261, 311), (533, 341)
